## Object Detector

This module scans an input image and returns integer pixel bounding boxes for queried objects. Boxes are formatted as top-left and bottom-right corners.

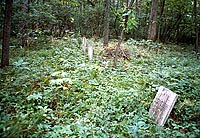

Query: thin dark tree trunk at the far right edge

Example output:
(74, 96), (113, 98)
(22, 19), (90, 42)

(194, 0), (199, 53)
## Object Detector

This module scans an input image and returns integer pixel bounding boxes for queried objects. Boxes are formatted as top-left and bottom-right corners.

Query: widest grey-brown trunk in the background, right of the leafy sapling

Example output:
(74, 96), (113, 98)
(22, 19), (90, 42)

(147, 0), (158, 41)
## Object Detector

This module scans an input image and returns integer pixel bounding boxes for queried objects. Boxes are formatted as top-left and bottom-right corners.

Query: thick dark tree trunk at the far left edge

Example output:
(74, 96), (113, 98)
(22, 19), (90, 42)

(1, 0), (13, 68)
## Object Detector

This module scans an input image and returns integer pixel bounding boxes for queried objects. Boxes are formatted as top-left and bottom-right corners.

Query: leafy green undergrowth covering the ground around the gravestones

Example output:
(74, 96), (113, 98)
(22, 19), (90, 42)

(0, 39), (200, 138)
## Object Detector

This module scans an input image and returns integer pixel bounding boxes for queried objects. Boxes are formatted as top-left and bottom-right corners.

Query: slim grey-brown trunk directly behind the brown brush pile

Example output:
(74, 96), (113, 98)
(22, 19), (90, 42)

(103, 0), (110, 46)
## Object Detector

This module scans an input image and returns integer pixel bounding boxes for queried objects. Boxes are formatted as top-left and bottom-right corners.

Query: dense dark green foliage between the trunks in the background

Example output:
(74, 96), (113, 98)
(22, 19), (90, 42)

(0, 0), (200, 45)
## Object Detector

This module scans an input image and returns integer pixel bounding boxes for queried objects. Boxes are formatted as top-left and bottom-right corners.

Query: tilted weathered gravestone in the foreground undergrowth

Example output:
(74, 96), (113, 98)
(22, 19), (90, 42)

(149, 86), (178, 126)
